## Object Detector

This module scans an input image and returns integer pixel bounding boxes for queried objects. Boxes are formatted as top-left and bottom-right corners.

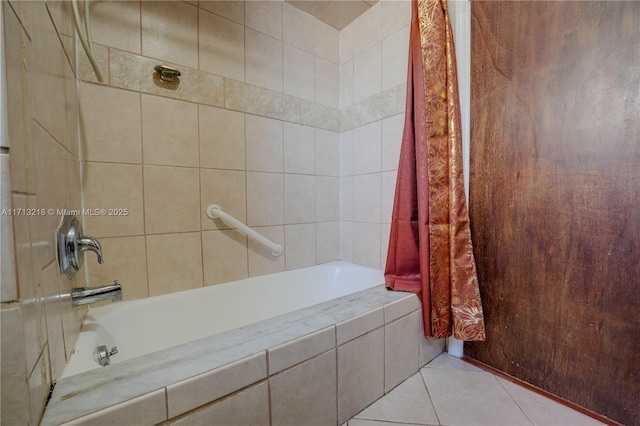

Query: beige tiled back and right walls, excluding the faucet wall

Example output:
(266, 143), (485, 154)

(79, 1), (410, 299)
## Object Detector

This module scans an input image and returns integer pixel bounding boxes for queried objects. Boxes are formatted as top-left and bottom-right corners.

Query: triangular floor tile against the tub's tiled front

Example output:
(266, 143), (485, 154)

(356, 373), (438, 426)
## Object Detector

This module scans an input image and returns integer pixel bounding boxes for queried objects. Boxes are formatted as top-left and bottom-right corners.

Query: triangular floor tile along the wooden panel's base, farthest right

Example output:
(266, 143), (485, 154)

(498, 379), (603, 426)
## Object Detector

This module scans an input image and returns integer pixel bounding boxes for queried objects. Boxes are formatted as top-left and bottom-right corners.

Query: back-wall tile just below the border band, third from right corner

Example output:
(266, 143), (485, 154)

(245, 115), (284, 172)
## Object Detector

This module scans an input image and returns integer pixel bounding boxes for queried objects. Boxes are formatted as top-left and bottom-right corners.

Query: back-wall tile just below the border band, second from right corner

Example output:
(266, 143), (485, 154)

(284, 123), (316, 175)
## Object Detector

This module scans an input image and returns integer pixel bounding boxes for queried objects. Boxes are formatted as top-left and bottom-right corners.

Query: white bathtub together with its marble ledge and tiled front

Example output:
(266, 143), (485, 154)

(40, 262), (444, 426)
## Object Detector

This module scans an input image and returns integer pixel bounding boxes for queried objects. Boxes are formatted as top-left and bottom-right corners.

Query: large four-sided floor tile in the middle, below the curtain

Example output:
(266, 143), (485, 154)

(420, 367), (532, 426)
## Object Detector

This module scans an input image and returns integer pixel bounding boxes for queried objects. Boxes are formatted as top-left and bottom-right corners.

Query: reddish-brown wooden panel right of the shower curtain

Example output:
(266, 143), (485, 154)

(465, 1), (640, 424)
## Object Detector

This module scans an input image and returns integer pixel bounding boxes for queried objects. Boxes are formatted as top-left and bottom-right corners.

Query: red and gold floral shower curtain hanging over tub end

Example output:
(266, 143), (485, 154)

(385, 0), (485, 340)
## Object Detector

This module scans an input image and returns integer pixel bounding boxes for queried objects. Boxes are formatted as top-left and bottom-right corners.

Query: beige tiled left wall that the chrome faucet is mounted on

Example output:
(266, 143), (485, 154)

(1, 1), (86, 424)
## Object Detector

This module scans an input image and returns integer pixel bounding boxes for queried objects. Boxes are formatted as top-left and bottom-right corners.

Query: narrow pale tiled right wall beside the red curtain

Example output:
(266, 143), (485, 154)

(339, 0), (411, 268)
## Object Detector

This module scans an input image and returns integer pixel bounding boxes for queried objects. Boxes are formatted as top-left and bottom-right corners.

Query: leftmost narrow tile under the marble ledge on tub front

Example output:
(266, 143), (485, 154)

(65, 389), (167, 426)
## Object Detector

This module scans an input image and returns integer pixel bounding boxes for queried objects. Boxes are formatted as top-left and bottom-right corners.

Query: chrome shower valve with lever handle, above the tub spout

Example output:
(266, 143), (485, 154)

(56, 215), (103, 279)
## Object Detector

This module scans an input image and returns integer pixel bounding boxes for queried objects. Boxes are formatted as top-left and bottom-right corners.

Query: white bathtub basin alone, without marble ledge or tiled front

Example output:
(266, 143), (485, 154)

(62, 262), (384, 378)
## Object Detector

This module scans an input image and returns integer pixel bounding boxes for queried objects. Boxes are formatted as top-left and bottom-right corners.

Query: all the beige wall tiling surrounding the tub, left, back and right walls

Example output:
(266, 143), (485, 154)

(1, 1), (410, 424)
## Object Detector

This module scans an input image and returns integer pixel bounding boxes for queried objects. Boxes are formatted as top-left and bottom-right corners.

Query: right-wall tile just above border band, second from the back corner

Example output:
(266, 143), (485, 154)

(353, 43), (382, 102)
